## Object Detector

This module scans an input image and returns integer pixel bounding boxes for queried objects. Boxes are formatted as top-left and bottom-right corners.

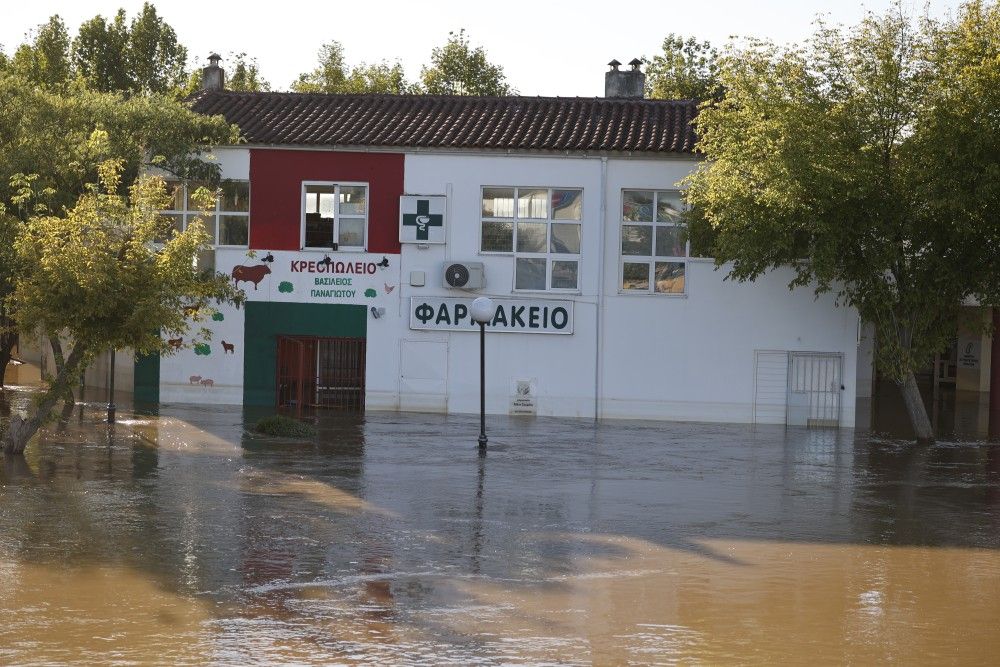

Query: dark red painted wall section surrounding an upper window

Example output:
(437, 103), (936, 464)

(250, 149), (403, 254)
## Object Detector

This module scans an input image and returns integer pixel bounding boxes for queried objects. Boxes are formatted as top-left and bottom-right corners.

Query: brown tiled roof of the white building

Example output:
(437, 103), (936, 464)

(191, 91), (697, 153)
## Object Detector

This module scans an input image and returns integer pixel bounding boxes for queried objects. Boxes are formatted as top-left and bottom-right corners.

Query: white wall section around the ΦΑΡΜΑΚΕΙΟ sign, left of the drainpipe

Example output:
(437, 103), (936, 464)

(398, 154), (601, 417)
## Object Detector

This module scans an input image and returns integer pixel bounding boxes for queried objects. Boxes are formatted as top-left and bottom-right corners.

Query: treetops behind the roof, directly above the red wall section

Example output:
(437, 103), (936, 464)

(292, 41), (413, 95)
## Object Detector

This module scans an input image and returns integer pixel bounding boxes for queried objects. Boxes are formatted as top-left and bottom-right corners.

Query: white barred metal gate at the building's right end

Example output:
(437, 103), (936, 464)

(786, 352), (844, 427)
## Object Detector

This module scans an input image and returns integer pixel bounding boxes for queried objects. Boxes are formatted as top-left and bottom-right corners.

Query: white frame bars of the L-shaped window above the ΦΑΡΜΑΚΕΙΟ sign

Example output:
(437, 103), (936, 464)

(477, 185), (585, 294)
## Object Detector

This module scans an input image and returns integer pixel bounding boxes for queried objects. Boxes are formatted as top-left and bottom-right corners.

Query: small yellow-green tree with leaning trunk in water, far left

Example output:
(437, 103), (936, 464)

(3, 153), (237, 454)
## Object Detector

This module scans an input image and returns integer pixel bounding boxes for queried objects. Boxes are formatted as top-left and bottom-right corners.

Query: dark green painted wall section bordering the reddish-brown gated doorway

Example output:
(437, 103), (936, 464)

(243, 301), (368, 406)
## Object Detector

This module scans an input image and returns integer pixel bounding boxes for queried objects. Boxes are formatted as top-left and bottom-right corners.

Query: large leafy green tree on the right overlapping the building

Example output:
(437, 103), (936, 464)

(686, 0), (1000, 440)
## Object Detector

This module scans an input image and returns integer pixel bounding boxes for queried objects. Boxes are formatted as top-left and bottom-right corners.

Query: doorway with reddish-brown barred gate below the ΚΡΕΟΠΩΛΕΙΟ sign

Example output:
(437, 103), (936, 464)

(276, 336), (365, 414)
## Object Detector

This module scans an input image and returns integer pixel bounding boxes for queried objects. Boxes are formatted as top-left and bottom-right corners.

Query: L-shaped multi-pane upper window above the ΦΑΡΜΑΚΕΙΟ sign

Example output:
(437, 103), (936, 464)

(479, 187), (583, 291)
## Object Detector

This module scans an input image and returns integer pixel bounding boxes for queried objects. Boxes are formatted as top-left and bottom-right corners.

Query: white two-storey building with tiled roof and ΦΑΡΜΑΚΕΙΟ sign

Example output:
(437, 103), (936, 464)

(121, 61), (859, 426)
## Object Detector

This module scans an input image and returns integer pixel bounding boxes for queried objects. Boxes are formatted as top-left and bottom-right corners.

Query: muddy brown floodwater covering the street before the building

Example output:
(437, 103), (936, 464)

(0, 392), (1000, 665)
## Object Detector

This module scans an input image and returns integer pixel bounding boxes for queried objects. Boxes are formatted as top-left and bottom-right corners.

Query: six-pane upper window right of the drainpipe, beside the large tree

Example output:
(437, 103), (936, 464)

(621, 190), (688, 294)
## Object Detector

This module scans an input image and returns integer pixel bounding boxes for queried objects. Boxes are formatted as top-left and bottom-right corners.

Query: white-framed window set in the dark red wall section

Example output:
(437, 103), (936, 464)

(302, 182), (368, 251)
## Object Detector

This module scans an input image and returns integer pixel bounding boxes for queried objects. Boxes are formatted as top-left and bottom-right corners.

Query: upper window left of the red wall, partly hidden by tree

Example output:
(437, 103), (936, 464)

(160, 180), (250, 246)
